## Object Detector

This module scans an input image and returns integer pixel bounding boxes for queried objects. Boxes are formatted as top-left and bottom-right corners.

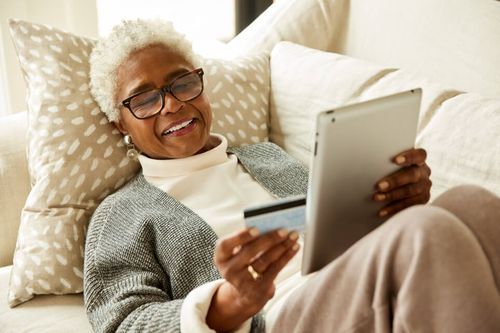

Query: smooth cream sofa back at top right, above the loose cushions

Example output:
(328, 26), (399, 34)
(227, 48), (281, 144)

(330, 0), (500, 97)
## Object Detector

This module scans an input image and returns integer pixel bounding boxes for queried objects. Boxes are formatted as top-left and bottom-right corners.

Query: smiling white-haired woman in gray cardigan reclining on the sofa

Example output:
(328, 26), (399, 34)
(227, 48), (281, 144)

(84, 20), (500, 332)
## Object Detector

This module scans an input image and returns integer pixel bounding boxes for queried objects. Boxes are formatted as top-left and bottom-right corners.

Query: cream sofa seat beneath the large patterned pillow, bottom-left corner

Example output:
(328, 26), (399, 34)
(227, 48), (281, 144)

(0, 266), (92, 333)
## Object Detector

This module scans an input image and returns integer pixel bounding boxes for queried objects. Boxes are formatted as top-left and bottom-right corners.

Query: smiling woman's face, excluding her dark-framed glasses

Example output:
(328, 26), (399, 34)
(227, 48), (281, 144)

(115, 45), (213, 159)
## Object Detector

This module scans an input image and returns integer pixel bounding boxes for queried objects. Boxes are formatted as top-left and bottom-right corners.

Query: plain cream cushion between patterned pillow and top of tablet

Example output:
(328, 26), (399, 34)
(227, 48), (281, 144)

(269, 42), (391, 164)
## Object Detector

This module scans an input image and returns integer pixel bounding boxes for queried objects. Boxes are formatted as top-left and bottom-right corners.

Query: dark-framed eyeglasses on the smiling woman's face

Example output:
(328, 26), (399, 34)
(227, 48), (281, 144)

(122, 68), (203, 119)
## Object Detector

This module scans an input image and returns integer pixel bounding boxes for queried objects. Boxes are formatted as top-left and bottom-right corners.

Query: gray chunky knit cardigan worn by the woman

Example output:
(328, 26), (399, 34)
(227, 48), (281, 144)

(84, 143), (308, 332)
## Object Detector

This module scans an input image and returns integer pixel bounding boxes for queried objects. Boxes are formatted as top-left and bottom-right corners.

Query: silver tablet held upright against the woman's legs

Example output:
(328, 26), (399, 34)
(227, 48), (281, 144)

(302, 89), (422, 274)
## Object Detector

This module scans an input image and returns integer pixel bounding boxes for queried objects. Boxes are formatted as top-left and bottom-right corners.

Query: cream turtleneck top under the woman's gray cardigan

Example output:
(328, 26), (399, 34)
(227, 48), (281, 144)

(139, 134), (275, 237)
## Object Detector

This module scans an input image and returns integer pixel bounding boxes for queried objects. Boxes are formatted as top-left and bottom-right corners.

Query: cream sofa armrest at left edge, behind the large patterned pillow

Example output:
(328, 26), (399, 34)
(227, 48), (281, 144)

(0, 112), (30, 266)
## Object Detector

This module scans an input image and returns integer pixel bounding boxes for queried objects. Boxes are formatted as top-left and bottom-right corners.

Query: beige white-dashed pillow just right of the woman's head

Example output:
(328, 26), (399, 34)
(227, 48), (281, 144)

(203, 54), (270, 146)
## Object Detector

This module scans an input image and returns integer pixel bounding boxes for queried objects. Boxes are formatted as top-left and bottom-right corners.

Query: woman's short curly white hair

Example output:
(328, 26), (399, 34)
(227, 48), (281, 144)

(90, 19), (201, 122)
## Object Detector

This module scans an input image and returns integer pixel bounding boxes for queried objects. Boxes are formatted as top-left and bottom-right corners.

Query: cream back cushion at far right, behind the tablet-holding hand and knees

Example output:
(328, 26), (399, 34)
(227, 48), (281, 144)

(417, 94), (500, 197)
